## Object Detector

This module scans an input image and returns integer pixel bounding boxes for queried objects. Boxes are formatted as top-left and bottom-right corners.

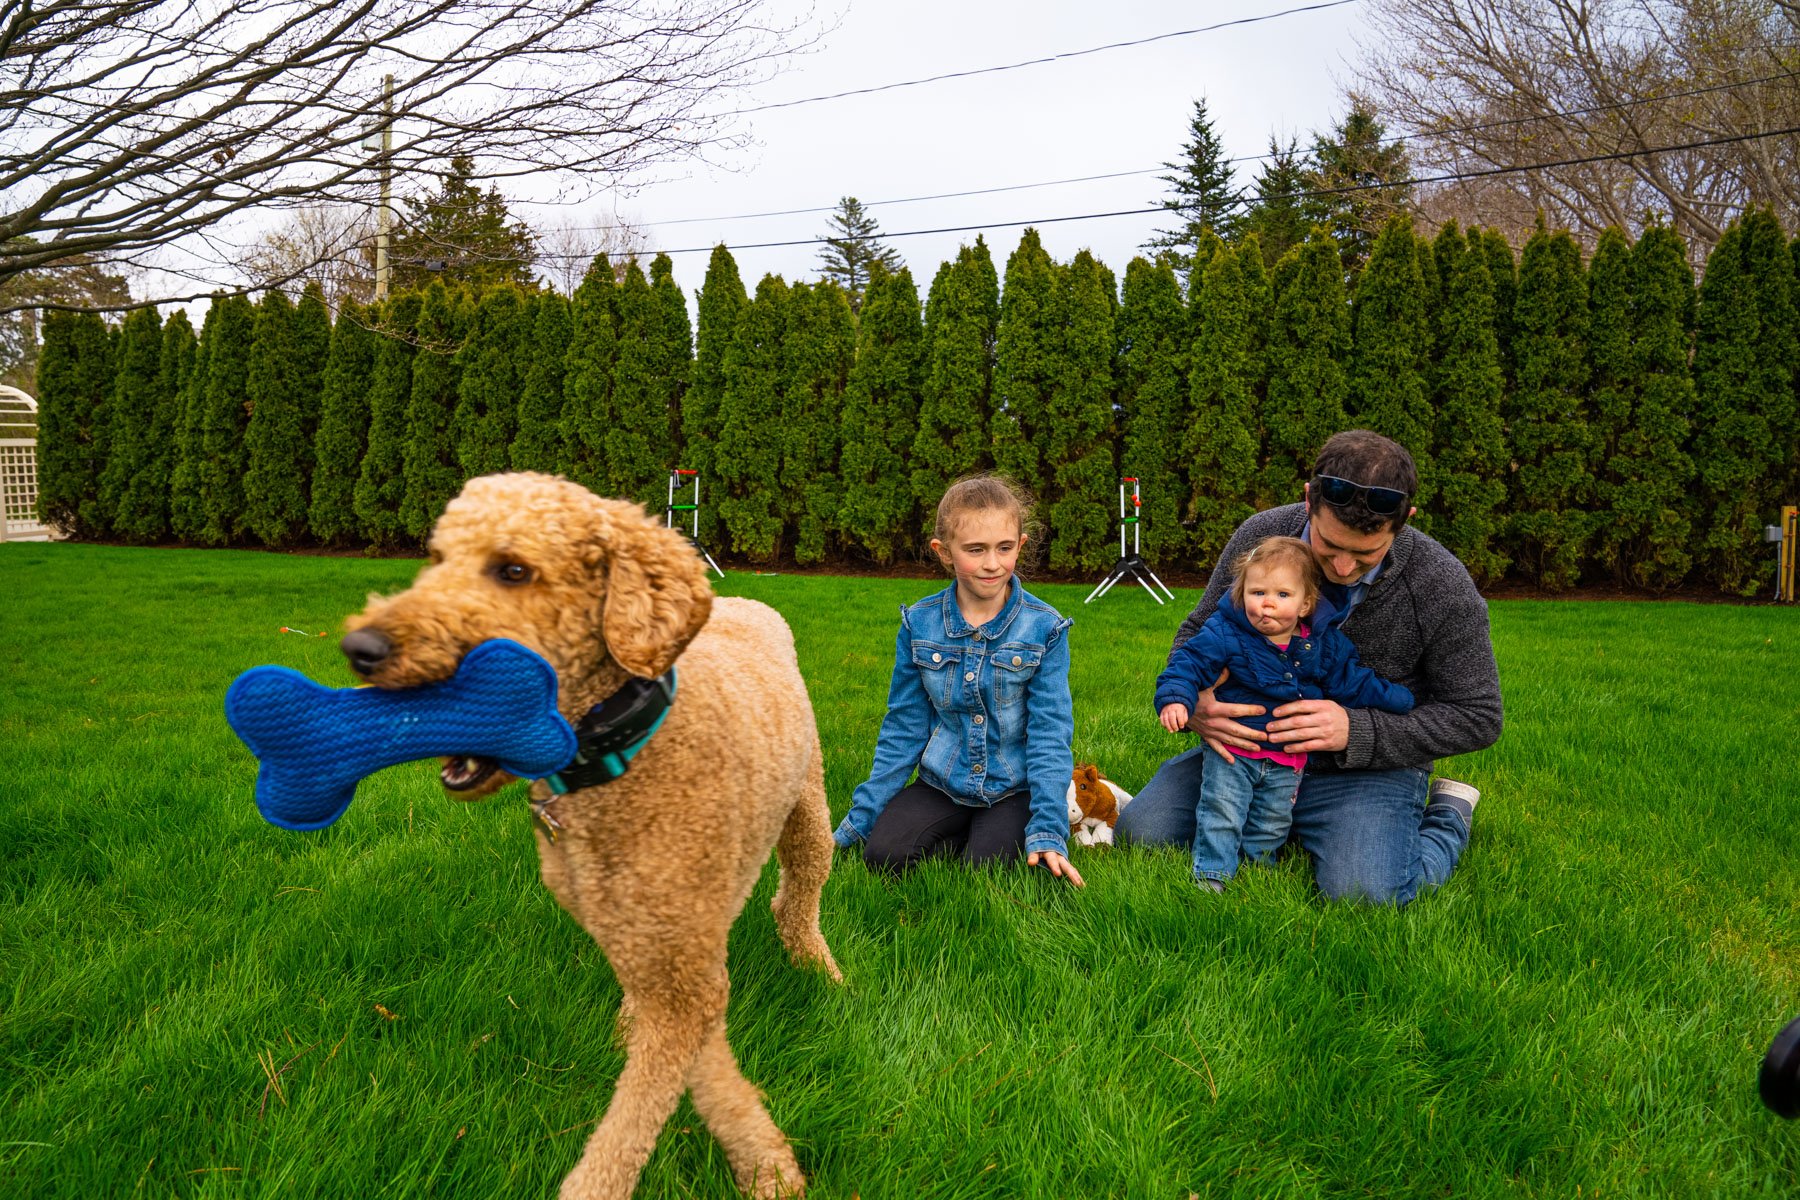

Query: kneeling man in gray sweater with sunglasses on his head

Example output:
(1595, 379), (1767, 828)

(1118, 430), (1501, 905)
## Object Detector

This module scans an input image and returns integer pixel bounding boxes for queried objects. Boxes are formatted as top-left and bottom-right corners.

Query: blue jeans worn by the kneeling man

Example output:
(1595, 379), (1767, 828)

(1118, 743), (1469, 905)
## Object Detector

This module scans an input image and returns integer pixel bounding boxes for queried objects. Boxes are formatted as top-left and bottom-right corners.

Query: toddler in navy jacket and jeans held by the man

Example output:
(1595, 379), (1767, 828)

(1156, 538), (1413, 892)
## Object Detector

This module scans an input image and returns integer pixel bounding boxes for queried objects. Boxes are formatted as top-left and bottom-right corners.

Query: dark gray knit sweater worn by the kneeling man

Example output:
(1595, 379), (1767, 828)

(1170, 504), (1501, 770)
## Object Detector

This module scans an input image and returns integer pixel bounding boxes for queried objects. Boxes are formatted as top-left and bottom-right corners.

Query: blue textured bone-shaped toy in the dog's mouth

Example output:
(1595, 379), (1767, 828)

(225, 639), (576, 829)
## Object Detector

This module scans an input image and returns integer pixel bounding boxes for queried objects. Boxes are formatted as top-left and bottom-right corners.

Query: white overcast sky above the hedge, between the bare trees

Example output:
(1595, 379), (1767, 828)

(506, 0), (1364, 297)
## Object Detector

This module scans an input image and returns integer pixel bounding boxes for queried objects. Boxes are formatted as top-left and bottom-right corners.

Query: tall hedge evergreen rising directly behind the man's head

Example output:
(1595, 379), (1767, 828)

(1346, 216), (1435, 527)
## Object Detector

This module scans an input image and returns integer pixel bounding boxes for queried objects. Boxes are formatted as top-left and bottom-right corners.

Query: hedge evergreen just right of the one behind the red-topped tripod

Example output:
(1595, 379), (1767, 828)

(1183, 239), (1269, 565)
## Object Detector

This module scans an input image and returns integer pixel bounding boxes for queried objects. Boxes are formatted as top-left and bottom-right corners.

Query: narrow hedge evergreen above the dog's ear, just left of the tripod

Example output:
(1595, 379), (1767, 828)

(603, 261), (675, 509)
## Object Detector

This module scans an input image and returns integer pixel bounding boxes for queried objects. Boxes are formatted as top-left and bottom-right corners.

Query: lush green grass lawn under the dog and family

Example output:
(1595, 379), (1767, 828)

(10, 545), (1800, 1200)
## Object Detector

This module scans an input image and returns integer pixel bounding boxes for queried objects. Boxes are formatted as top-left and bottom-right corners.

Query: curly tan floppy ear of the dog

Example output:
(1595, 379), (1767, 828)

(601, 504), (713, 678)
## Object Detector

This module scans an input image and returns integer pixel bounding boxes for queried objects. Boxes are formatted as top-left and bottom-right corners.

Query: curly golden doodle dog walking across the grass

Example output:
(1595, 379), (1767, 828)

(344, 473), (841, 1200)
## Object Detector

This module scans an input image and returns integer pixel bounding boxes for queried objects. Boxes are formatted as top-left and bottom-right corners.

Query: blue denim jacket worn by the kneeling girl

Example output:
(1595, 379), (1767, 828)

(835, 576), (1075, 855)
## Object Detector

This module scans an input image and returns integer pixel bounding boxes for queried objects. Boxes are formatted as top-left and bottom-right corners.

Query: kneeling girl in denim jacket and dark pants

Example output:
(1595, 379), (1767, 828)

(835, 475), (1082, 887)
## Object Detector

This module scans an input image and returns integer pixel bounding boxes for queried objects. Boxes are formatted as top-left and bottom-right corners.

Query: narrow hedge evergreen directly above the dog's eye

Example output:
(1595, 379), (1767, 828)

(450, 286), (531, 479)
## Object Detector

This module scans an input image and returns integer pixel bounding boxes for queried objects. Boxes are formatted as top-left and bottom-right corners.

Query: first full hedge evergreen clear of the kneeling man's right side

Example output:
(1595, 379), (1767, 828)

(1505, 223), (1598, 590)
